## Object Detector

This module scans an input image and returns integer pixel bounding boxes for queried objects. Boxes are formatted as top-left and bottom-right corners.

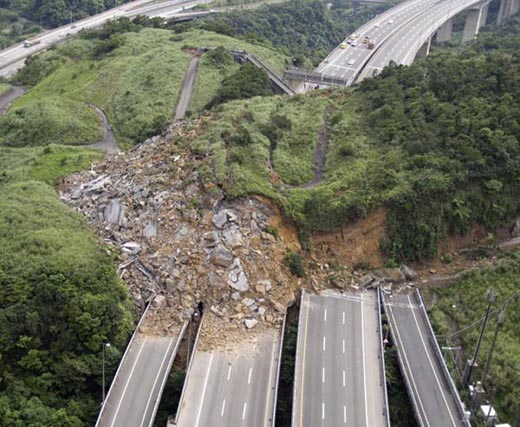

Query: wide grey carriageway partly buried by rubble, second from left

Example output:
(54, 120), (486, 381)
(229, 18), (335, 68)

(176, 330), (281, 427)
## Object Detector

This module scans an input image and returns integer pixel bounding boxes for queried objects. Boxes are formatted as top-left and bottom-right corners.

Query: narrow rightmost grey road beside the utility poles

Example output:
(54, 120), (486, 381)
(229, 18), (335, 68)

(385, 295), (464, 427)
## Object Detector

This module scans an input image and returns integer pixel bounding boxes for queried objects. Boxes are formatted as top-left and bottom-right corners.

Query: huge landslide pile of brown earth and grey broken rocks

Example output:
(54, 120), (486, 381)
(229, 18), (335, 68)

(60, 132), (298, 340)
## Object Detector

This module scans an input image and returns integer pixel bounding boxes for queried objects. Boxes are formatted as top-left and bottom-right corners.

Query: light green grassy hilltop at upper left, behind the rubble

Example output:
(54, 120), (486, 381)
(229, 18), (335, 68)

(0, 29), (285, 145)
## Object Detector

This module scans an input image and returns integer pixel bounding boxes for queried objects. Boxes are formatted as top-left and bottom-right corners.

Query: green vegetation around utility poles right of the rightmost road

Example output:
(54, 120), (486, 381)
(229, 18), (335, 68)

(426, 251), (520, 425)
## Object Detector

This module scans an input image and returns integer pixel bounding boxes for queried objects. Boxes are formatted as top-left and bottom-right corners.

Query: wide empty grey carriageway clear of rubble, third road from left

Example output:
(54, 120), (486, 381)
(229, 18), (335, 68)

(292, 291), (387, 427)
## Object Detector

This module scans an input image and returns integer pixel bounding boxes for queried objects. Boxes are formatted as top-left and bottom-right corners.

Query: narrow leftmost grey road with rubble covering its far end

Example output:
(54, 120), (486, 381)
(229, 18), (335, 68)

(96, 327), (185, 427)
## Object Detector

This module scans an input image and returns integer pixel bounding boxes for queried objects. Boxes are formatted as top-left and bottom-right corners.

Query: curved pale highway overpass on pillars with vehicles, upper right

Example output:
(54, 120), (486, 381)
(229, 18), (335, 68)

(293, 0), (520, 92)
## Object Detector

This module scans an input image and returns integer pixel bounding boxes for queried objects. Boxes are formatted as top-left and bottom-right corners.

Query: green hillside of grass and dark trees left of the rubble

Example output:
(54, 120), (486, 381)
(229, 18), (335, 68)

(0, 145), (134, 427)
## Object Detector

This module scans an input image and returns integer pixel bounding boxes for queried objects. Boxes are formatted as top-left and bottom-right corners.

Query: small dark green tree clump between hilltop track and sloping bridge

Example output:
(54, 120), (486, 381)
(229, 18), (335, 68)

(209, 62), (273, 107)
